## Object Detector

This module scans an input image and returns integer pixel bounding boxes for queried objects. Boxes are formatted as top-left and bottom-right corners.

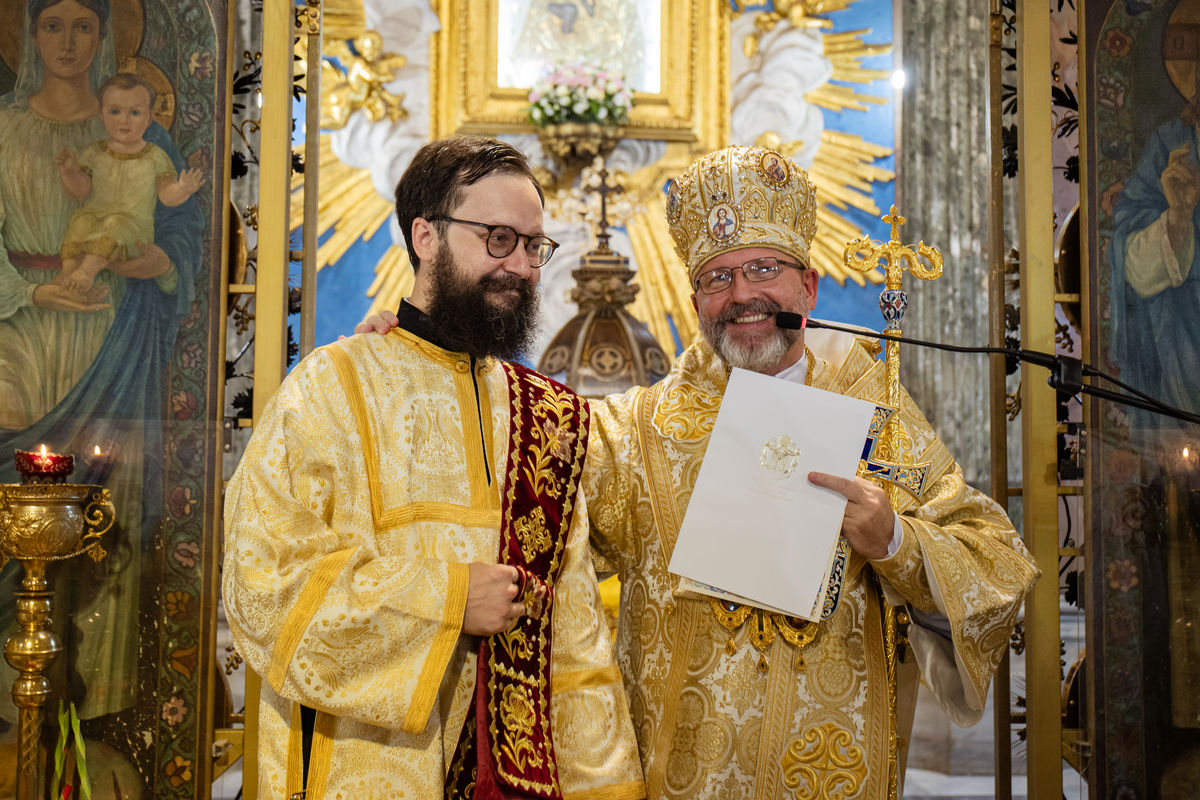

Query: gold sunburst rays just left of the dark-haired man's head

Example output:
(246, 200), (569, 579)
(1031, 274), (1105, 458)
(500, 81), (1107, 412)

(289, 134), (413, 314)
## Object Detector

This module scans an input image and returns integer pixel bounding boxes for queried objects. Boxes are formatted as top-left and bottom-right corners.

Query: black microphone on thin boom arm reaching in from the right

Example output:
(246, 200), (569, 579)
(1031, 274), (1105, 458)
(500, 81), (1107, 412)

(775, 311), (1200, 423)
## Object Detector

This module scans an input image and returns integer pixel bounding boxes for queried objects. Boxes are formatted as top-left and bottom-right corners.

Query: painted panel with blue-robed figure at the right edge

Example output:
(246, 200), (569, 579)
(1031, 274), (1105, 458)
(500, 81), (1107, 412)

(1085, 0), (1200, 798)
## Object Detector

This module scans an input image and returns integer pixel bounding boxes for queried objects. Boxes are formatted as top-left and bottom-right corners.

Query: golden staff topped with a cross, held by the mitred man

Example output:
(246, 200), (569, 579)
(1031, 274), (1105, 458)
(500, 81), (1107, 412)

(844, 205), (942, 800)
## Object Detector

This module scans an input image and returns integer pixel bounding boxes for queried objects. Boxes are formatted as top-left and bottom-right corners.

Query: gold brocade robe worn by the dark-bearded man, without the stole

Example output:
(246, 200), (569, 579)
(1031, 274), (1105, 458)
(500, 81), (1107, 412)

(222, 330), (644, 800)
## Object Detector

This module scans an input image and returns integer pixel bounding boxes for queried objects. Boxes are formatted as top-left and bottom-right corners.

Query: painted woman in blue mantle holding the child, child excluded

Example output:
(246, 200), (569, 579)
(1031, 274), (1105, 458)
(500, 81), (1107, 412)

(0, 0), (205, 718)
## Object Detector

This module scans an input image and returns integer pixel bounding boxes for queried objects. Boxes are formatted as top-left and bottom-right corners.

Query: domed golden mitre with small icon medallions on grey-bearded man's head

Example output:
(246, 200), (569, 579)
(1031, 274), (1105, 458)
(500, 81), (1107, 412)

(667, 146), (817, 276)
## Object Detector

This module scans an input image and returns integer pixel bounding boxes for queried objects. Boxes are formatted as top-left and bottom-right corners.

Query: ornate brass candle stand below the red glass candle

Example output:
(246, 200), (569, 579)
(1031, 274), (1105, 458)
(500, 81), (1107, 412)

(0, 482), (115, 800)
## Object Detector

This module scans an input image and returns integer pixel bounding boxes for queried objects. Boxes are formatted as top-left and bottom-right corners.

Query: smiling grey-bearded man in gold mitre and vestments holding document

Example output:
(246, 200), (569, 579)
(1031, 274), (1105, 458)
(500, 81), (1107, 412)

(355, 146), (1038, 800)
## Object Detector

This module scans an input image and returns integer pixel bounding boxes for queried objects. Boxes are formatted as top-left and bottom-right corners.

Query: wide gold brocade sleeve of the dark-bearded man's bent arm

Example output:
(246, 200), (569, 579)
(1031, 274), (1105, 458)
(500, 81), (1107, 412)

(222, 351), (467, 733)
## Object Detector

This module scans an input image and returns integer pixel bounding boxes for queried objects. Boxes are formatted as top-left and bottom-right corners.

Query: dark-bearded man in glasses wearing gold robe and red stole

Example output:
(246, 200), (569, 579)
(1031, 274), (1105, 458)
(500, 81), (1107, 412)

(223, 137), (644, 800)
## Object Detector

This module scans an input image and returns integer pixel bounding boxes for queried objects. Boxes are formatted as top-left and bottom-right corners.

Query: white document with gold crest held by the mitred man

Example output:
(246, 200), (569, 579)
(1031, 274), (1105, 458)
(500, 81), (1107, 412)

(668, 369), (875, 620)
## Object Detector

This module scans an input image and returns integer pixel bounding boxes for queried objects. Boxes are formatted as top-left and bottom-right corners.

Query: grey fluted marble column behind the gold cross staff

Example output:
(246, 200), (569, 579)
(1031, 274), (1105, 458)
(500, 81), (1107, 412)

(896, 0), (990, 489)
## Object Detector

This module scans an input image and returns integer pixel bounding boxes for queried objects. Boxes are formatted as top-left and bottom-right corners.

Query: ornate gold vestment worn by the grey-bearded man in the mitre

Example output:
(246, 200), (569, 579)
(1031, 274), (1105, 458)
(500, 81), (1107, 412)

(583, 341), (1037, 800)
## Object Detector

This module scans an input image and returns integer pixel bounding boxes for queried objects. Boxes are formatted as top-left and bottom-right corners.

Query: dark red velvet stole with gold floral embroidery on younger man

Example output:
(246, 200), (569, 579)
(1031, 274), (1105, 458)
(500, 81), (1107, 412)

(445, 362), (588, 800)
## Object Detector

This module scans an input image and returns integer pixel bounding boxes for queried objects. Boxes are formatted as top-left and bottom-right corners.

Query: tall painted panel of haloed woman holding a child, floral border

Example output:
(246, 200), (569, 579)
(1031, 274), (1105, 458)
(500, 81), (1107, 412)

(0, 0), (229, 798)
